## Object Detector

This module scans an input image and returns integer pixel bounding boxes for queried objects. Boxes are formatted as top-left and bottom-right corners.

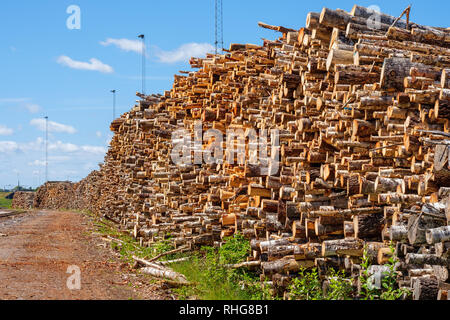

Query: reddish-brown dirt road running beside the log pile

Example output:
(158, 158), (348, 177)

(0, 211), (167, 300)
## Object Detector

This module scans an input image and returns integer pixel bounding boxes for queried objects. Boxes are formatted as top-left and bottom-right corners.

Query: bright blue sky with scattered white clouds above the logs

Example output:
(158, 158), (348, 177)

(0, 0), (450, 188)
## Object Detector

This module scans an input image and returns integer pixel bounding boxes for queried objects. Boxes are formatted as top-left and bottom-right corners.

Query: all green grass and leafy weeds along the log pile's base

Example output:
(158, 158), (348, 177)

(79, 212), (414, 300)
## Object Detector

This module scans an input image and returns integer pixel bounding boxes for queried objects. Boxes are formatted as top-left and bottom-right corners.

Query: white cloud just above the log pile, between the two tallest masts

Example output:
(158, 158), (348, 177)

(156, 43), (214, 63)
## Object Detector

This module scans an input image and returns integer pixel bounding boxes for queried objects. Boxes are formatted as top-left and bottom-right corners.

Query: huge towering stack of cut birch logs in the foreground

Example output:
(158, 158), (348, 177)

(14, 6), (450, 299)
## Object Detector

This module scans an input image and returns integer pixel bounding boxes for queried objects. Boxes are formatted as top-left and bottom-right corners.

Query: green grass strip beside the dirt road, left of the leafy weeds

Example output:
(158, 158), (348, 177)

(81, 212), (270, 300)
